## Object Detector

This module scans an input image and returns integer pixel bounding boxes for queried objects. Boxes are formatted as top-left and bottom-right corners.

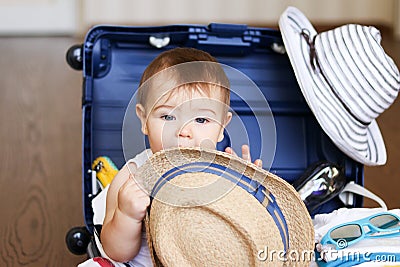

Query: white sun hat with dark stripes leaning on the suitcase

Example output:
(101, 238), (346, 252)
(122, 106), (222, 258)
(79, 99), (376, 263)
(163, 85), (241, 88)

(279, 7), (400, 165)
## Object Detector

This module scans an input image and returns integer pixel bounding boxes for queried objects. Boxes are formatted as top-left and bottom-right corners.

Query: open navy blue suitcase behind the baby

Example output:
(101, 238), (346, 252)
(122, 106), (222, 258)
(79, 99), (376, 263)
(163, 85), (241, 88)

(67, 24), (363, 258)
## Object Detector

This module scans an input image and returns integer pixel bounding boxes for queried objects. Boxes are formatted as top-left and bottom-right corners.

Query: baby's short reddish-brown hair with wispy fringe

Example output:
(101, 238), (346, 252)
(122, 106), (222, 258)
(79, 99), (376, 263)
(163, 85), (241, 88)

(137, 48), (230, 107)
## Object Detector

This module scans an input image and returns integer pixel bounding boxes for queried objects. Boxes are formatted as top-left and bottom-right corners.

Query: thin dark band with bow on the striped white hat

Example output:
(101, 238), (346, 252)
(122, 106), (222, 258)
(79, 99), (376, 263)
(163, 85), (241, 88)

(300, 29), (370, 126)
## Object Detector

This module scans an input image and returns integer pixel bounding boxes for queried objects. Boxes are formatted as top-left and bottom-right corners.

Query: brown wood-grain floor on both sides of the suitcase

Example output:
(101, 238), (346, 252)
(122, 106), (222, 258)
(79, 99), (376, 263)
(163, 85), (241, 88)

(0, 29), (400, 266)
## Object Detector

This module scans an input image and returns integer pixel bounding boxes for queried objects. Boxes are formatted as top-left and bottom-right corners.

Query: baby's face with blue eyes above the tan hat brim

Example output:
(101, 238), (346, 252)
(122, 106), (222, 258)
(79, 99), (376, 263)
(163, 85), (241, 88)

(138, 90), (232, 153)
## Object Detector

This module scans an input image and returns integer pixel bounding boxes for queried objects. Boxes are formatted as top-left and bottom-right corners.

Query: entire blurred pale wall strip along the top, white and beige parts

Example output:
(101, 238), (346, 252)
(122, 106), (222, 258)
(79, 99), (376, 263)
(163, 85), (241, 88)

(0, 0), (394, 36)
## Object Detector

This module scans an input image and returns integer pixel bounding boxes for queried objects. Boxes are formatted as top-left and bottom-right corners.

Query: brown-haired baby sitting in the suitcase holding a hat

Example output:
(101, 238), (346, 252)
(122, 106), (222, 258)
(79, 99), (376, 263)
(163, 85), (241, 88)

(101, 48), (262, 266)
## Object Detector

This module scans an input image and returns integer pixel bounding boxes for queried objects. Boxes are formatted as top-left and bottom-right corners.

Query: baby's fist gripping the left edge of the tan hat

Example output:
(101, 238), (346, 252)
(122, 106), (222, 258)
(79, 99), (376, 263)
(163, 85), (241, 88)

(118, 174), (150, 222)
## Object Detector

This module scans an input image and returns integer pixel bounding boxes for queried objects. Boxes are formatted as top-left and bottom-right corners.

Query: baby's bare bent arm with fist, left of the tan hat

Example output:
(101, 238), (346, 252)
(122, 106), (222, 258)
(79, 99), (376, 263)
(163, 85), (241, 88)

(101, 163), (150, 262)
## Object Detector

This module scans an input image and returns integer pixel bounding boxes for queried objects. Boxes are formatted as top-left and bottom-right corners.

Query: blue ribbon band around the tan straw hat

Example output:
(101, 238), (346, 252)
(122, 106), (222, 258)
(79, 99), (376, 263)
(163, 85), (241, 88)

(151, 162), (289, 252)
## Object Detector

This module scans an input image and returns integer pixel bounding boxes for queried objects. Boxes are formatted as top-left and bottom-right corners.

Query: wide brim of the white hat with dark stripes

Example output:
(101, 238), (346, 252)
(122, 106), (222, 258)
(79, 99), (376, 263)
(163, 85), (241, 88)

(279, 7), (386, 166)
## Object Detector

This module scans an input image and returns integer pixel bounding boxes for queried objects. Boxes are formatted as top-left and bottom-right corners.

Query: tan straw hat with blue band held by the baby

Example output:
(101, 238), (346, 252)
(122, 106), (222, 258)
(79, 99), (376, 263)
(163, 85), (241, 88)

(135, 148), (314, 266)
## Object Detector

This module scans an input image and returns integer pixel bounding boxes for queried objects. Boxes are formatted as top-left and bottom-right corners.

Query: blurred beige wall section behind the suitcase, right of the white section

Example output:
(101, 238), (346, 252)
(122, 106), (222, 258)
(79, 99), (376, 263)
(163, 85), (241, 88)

(81, 0), (396, 28)
